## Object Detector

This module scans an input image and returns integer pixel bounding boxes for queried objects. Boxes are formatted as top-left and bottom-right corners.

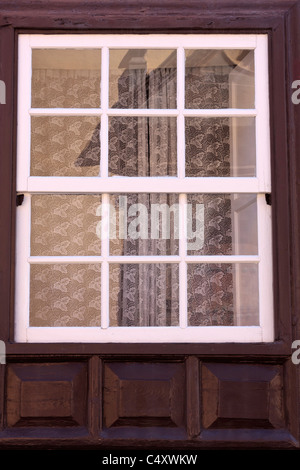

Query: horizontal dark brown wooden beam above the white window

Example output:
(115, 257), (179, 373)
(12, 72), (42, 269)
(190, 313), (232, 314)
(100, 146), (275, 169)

(0, 0), (295, 32)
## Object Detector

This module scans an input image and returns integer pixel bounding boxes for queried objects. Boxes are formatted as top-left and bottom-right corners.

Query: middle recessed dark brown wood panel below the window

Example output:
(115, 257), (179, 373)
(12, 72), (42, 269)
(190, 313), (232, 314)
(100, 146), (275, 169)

(103, 363), (186, 436)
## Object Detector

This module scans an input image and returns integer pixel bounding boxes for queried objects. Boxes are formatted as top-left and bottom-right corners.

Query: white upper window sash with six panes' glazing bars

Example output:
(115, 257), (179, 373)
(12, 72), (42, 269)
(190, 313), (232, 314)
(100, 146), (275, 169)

(17, 34), (271, 193)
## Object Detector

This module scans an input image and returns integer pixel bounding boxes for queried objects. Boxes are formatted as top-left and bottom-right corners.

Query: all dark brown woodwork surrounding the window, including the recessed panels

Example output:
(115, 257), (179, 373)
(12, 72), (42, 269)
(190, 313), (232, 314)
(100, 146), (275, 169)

(0, 0), (300, 451)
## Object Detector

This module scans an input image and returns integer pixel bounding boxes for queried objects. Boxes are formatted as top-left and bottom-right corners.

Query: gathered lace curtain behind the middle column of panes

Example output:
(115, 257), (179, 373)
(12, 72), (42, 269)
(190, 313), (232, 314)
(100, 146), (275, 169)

(109, 64), (179, 326)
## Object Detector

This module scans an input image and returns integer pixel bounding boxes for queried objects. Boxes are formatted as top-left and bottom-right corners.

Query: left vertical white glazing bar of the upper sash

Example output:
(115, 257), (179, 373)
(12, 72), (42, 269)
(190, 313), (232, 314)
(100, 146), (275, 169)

(100, 47), (109, 178)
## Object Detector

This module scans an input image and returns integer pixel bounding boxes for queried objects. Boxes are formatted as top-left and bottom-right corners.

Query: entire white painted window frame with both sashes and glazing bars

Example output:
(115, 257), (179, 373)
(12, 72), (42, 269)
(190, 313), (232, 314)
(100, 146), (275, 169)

(15, 34), (274, 343)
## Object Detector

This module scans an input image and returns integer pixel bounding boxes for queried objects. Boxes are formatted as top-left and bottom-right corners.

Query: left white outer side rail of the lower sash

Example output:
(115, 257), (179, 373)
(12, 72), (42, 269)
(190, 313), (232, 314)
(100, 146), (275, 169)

(15, 195), (31, 342)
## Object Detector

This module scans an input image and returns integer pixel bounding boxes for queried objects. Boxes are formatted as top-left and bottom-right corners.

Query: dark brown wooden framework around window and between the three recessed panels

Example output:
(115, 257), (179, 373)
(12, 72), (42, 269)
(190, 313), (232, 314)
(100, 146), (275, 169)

(0, 0), (300, 449)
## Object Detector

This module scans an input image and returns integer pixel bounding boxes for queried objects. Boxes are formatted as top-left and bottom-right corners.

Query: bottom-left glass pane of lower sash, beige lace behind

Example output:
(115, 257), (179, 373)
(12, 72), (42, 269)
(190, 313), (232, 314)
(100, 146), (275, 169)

(30, 264), (101, 326)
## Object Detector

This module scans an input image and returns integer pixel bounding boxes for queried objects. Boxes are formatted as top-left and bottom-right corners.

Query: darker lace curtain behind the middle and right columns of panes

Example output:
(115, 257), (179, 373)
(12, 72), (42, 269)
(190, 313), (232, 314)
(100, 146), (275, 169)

(109, 64), (233, 326)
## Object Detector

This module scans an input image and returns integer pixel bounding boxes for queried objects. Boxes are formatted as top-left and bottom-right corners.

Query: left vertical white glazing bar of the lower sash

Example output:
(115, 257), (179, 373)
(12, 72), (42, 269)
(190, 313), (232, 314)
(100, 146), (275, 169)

(101, 194), (110, 329)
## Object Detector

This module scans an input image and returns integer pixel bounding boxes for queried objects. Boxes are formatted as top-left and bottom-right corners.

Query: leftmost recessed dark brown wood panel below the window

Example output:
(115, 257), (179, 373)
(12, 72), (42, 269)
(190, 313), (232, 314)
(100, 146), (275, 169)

(7, 363), (87, 426)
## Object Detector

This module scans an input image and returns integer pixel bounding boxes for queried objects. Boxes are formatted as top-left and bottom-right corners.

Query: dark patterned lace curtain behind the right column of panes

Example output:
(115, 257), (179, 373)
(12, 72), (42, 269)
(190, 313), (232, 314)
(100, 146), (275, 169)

(185, 66), (234, 326)
